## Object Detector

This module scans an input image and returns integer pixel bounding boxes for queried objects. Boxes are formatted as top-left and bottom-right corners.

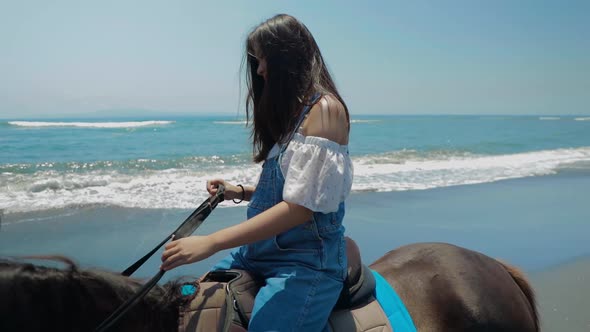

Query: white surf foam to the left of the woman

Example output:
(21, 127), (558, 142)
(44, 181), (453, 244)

(0, 165), (260, 213)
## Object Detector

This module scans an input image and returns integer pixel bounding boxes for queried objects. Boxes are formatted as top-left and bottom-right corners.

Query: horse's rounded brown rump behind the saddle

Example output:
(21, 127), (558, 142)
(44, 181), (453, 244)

(370, 243), (539, 332)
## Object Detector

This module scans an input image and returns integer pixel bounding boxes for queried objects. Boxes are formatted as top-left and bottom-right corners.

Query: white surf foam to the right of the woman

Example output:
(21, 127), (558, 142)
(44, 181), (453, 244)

(353, 147), (590, 191)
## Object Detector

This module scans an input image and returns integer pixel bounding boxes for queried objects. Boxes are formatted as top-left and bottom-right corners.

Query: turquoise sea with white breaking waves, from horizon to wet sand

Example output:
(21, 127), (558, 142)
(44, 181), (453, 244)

(0, 114), (590, 213)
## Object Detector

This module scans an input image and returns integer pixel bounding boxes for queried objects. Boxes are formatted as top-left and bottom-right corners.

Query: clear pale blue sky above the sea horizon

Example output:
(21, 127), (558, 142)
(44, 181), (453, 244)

(0, 0), (590, 118)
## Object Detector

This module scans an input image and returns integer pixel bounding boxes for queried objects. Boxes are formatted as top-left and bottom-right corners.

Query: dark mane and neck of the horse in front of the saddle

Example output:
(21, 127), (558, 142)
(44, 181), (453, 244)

(0, 256), (184, 331)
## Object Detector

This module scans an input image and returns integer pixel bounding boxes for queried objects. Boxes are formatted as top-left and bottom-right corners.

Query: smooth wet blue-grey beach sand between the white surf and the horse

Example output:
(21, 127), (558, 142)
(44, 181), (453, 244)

(0, 172), (590, 331)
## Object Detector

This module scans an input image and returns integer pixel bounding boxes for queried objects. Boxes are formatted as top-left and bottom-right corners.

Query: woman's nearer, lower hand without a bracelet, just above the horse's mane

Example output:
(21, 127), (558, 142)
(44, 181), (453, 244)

(160, 236), (217, 271)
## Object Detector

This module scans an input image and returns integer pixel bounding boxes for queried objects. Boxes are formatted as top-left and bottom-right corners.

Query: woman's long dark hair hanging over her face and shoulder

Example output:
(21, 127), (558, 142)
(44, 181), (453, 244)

(246, 14), (348, 162)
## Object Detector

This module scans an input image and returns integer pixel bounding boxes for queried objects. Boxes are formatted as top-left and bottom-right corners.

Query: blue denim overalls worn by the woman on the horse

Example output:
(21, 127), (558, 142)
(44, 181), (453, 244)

(213, 97), (347, 332)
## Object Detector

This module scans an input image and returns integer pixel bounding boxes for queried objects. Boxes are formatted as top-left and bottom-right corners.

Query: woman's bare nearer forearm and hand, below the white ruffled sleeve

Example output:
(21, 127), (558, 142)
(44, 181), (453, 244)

(160, 201), (313, 271)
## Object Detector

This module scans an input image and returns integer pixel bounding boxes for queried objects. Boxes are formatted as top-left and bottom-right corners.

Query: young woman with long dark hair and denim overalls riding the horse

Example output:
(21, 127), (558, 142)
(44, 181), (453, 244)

(162, 15), (353, 331)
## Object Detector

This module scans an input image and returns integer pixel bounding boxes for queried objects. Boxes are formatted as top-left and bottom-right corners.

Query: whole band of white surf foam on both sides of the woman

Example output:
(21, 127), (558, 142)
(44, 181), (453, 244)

(0, 147), (590, 213)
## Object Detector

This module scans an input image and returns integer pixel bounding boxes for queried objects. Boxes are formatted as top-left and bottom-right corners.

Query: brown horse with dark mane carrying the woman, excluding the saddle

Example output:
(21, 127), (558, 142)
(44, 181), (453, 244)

(0, 243), (539, 332)
